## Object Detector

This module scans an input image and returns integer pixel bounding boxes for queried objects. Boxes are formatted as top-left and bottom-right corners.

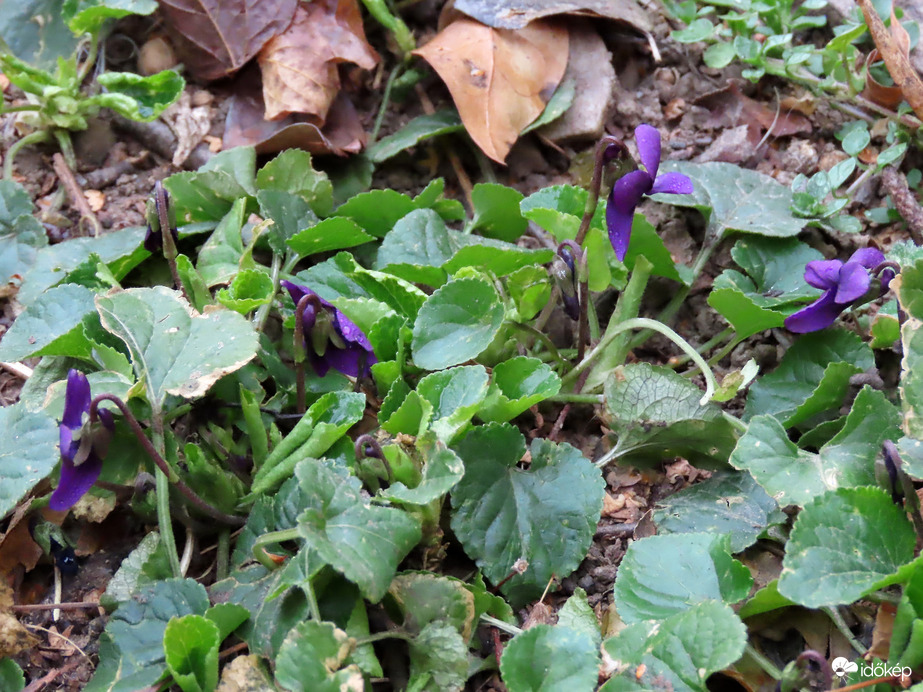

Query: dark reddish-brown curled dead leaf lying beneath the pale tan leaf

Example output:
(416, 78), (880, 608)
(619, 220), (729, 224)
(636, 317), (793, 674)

(222, 73), (366, 156)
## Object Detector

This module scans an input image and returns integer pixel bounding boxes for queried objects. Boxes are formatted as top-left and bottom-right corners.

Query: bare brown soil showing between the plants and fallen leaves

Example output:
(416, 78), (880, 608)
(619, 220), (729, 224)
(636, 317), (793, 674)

(0, 3), (903, 690)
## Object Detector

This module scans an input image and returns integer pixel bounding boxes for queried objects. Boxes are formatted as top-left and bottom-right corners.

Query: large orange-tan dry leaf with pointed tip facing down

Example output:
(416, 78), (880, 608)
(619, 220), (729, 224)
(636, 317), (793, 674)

(414, 19), (568, 163)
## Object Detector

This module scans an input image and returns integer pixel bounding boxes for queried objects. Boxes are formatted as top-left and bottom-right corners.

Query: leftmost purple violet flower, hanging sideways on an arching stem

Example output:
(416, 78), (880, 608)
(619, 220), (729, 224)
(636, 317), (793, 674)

(48, 369), (115, 512)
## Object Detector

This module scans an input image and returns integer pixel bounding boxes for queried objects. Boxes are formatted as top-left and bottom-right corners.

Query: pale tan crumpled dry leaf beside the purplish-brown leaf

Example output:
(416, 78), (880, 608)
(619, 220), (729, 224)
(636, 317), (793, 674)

(259, 0), (378, 123)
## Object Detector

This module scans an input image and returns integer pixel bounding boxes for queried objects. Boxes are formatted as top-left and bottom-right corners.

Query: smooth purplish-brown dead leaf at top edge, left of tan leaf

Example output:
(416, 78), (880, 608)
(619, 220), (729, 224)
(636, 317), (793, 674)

(160, 0), (298, 81)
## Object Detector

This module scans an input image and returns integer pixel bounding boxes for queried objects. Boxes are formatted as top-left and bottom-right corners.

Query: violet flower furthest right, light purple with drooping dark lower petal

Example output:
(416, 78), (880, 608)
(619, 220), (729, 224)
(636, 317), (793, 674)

(785, 247), (894, 334)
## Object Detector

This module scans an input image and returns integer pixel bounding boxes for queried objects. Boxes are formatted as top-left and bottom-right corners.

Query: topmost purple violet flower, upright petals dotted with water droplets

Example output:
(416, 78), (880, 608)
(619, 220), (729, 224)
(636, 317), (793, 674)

(606, 125), (693, 262)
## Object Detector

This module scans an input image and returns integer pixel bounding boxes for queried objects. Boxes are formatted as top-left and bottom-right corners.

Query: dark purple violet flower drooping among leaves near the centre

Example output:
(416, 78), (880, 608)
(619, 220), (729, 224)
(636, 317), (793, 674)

(282, 281), (378, 377)
